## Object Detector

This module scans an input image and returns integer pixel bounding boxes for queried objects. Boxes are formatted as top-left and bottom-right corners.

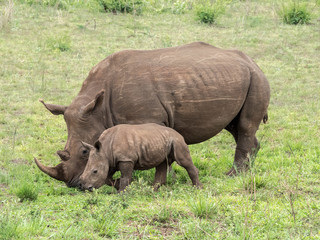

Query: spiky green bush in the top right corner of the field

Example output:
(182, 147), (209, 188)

(278, 1), (311, 25)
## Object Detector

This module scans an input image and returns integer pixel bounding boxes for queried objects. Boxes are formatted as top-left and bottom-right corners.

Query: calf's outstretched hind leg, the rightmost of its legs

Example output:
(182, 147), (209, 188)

(173, 142), (201, 188)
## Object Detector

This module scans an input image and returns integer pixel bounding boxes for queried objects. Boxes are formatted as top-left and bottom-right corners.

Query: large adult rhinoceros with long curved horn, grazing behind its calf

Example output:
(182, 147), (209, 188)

(35, 42), (270, 187)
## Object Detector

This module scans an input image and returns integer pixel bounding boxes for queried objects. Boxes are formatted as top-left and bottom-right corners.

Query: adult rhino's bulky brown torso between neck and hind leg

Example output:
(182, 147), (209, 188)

(92, 43), (258, 144)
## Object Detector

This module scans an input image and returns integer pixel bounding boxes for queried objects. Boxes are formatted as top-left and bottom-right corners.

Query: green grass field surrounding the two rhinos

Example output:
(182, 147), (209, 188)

(0, 0), (320, 239)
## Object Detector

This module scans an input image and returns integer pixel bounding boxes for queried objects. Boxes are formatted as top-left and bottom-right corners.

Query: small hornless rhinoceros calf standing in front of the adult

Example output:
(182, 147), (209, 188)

(80, 123), (200, 192)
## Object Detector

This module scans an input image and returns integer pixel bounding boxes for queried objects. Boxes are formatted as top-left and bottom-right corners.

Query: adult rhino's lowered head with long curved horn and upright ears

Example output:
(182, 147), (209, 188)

(35, 91), (106, 187)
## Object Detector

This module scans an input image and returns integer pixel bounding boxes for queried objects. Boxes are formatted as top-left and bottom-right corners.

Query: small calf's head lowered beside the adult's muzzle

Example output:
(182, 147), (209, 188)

(80, 140), (109, 191)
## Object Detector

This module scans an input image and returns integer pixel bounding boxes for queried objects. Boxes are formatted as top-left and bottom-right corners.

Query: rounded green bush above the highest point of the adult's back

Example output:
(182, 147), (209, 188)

(195, 1), (225, 24)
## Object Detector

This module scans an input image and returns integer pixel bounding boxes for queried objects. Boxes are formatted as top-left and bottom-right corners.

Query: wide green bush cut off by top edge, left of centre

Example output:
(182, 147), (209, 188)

(97, 0), (143, 14)
